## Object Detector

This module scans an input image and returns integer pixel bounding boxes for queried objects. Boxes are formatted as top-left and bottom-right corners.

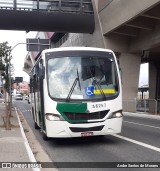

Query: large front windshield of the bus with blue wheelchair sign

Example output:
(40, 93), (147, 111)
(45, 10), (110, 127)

(47, 52), (119, 101)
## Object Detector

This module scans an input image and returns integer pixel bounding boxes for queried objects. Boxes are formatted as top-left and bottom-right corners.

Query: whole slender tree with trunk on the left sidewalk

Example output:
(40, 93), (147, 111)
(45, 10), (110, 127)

(0, 42), (12, 130)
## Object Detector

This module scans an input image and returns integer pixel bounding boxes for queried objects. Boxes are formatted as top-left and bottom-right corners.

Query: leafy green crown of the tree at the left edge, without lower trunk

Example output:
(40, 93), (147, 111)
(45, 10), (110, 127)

(0, 42), (12, 91)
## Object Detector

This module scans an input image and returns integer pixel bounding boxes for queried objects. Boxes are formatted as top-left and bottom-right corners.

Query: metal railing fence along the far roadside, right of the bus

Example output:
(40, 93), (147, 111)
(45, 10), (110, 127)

(123, 99), (160, 114)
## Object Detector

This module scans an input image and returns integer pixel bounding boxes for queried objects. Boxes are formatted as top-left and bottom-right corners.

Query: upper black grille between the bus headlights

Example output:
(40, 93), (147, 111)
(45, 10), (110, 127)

(64, 110), (109, 121)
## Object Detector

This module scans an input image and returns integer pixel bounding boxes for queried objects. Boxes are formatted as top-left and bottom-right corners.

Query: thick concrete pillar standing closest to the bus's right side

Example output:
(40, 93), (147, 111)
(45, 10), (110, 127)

(119, 53), (141, 112)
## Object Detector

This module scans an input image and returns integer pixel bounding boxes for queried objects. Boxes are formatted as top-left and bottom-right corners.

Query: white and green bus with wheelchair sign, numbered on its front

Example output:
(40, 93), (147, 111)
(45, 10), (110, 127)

(30, 47), (123, 139)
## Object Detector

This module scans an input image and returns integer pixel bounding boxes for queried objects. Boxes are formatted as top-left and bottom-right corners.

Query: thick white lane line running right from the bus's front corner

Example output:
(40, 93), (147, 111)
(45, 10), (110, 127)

(112, 134), (160, 152)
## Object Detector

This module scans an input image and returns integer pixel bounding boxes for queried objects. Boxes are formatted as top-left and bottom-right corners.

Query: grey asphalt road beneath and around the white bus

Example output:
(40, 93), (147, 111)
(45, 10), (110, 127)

(14, 100), (160, 171)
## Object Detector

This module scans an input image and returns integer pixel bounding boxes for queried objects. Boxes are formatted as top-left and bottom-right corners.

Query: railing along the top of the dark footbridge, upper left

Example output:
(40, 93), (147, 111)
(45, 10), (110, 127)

(0, 0), (93, 14)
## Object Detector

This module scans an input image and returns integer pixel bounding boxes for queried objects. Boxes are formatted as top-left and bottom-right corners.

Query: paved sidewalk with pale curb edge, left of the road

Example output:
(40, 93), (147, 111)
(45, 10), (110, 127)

(0, 103), (40, 171)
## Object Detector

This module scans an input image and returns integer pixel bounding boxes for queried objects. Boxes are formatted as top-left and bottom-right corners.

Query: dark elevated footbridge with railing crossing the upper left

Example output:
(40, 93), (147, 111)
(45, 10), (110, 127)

(0, 0), (94, 33)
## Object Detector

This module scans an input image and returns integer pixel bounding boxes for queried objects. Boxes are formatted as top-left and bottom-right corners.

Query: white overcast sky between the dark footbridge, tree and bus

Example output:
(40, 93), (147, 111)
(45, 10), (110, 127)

(0, 30), (37, 81)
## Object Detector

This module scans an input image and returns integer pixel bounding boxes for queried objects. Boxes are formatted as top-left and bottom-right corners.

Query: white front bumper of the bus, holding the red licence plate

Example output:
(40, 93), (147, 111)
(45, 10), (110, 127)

(46, 117), (123, 138)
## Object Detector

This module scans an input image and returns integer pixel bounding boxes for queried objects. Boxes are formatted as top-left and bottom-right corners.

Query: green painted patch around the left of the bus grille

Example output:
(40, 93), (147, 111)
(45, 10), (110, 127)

(56, 103), (87, 123)
